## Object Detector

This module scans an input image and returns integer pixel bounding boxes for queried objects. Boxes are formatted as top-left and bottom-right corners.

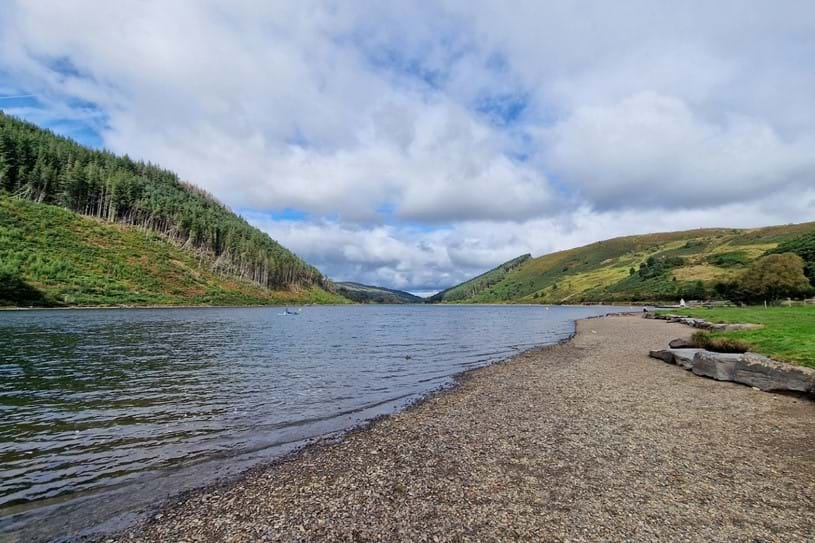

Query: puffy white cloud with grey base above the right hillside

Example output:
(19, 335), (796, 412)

(541, 92), (815, 209)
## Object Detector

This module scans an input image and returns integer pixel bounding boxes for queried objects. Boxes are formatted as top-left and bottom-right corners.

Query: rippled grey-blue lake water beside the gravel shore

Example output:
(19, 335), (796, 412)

(0, 305), (619, 540)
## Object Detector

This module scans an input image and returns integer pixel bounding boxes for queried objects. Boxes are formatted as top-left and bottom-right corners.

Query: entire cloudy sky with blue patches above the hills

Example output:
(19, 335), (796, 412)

(0, 0), (815, 293)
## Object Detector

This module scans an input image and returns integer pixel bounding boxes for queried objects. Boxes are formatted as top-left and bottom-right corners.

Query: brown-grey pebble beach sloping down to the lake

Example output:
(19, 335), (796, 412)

(108, 317), (815, 542)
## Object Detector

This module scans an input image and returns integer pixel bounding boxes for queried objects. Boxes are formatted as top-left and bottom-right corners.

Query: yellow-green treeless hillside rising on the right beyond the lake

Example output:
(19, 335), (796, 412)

(429, 223), (815, 303)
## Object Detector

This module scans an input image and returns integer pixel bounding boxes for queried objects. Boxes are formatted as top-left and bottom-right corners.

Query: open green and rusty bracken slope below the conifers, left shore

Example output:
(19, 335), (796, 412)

(0, 196), (347, 305)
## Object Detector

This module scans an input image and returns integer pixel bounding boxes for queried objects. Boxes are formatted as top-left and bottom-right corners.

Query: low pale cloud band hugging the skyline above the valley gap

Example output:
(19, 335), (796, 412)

(245, 188), (815, 293)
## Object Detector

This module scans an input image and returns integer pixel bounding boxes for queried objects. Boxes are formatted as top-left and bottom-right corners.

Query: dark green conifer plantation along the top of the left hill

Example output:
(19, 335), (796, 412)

(0, 112), (344, 306)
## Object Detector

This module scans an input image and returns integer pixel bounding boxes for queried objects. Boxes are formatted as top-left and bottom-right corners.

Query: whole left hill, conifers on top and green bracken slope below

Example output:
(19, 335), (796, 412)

(0, 112), (344, 305)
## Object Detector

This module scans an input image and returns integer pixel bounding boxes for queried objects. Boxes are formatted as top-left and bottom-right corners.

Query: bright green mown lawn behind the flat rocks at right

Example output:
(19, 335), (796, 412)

(671, 305), (815, 368)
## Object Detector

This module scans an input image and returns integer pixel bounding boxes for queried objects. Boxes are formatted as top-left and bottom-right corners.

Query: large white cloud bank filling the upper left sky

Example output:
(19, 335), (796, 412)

(3, 3), (551, 222)
